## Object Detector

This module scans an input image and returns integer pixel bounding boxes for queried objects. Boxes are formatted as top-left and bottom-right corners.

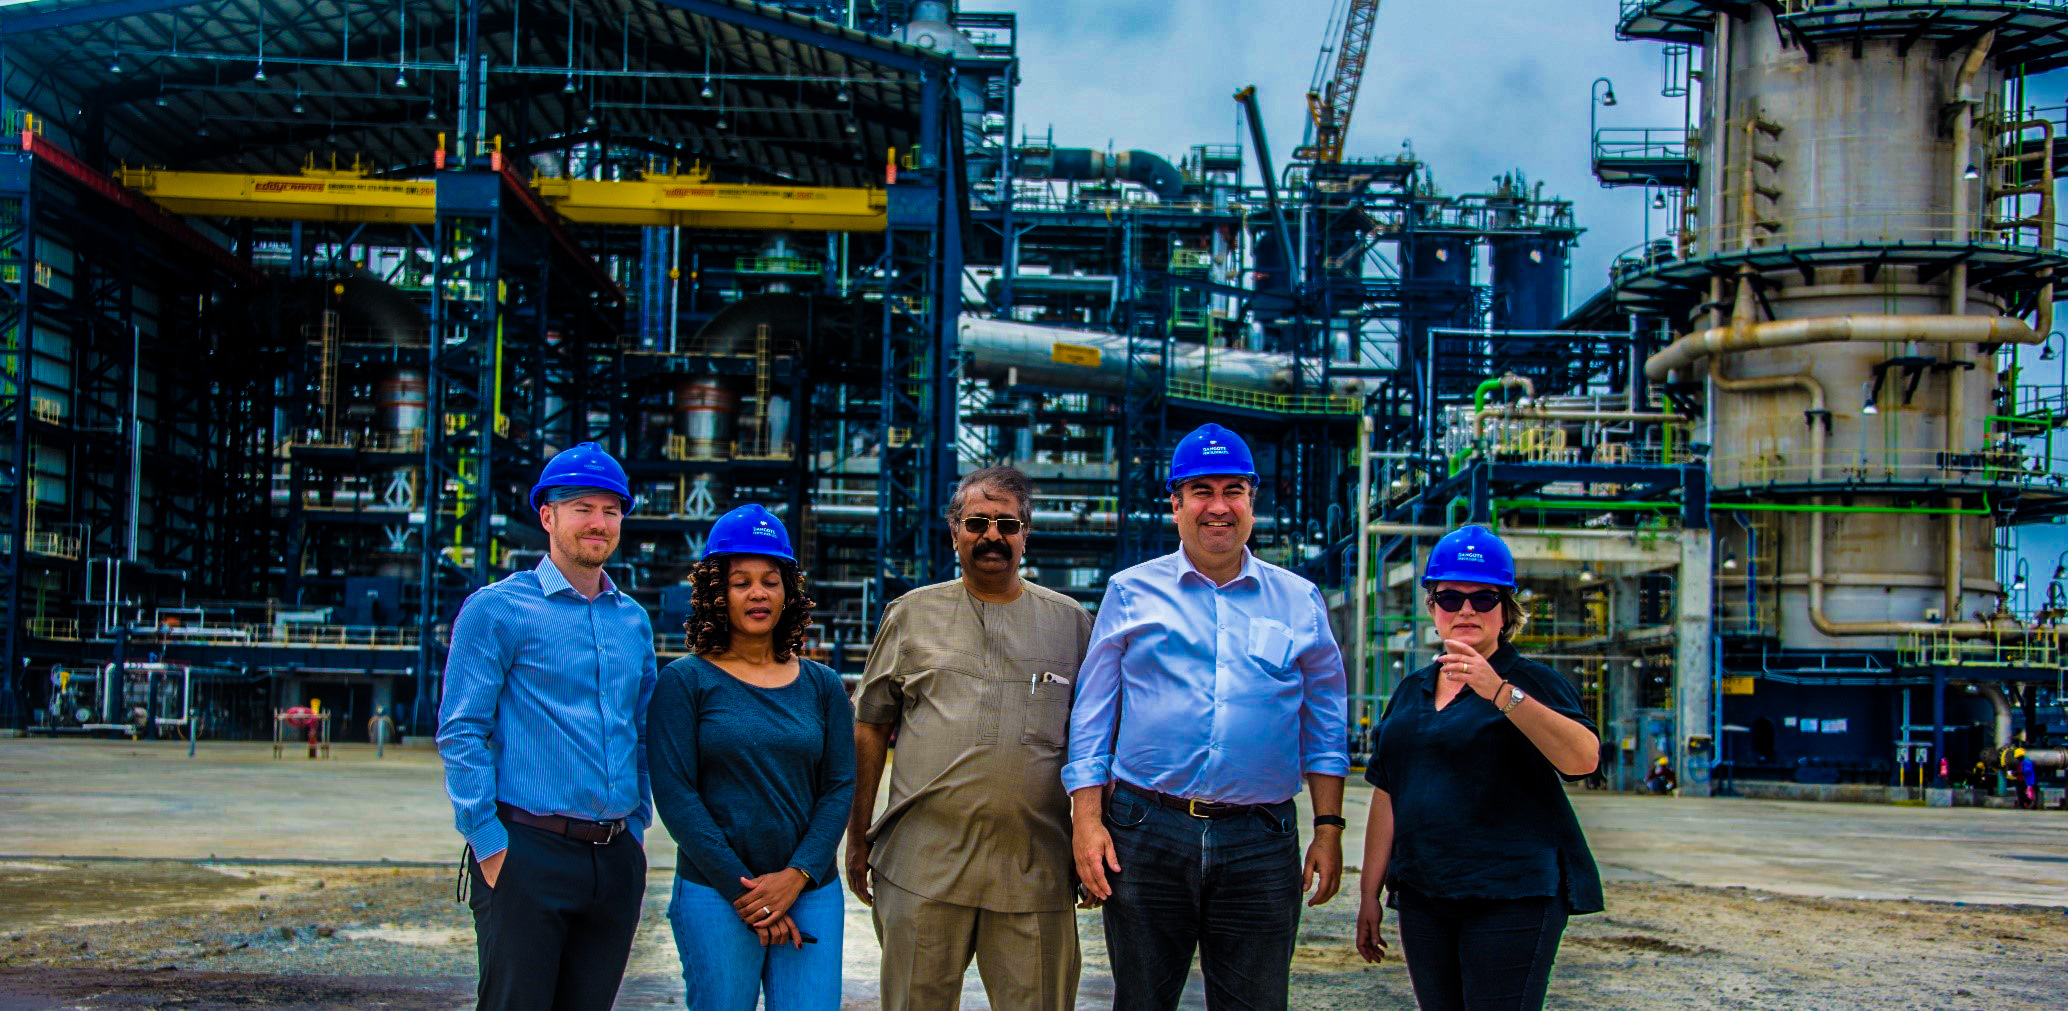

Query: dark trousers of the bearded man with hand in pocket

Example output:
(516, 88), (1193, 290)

(469, 819), (645, 1011)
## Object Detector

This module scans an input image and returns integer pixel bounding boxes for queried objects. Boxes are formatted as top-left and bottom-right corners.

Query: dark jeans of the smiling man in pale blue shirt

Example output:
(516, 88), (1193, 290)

(1104, 790), (1301, 1011)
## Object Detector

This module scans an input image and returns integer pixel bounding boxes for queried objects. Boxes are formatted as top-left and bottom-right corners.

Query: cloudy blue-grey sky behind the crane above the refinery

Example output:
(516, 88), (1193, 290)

(962, 0), (1681, 302)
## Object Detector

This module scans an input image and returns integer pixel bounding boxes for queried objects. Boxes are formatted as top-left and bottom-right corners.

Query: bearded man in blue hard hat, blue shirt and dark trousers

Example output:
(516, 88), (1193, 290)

(438, 442), (656, 1011)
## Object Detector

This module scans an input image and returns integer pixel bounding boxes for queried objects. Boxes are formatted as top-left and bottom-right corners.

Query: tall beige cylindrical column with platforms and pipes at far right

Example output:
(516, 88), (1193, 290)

(1617, 0), (2068, 784)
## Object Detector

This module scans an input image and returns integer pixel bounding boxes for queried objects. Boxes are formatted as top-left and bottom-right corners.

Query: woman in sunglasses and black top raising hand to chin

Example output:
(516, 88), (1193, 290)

(1357, 527), (1601, 1009)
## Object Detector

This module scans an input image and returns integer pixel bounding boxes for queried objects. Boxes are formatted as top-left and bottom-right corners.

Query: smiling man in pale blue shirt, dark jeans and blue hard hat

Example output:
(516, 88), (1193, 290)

(1063, 424), (1350, 1011)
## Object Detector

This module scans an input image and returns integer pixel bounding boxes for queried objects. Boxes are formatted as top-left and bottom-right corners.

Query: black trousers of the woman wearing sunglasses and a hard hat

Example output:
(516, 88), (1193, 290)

(1394, 889), (1565, 1011)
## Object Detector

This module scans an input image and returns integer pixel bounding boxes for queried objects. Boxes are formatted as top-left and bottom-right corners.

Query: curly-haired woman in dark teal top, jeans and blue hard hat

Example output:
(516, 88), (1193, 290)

(647, 504), (854, 1011)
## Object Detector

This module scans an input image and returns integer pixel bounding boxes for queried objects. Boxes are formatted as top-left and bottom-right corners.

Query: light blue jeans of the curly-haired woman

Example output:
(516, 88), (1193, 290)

(668, 877), (846, 1011)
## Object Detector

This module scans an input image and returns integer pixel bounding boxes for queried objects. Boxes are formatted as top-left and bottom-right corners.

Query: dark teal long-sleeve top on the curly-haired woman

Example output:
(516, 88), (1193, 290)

(647, 655), (854, 899)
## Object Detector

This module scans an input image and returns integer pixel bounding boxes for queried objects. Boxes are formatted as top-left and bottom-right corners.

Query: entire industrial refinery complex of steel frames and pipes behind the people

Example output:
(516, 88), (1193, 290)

(0, 0), (2068, 792)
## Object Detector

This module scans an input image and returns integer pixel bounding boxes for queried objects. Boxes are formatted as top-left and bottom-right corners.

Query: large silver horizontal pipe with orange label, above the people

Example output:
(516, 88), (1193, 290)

(960, 314), (1369, 397)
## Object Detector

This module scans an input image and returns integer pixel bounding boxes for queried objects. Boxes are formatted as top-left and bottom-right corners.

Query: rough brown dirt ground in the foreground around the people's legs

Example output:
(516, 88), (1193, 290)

(0, 860), (2068, 1011)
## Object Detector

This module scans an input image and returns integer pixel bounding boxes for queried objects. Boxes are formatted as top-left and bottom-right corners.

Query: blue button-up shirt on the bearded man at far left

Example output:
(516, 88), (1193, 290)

(438, 556), (656, 858)
